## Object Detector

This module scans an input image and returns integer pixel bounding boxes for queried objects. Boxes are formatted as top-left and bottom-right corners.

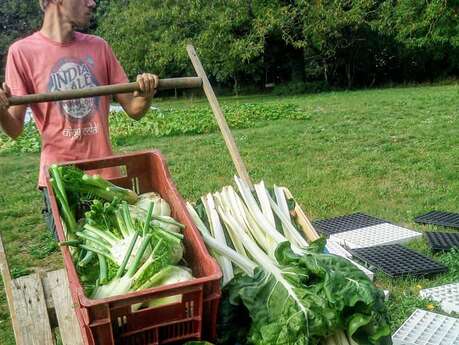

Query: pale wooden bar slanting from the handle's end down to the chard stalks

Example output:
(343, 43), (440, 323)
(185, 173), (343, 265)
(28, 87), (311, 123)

(186, 44), (253, 189)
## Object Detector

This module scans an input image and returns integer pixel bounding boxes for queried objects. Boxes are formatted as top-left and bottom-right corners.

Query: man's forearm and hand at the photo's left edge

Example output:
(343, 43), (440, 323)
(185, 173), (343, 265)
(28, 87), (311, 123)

(0, 83), (27, 139)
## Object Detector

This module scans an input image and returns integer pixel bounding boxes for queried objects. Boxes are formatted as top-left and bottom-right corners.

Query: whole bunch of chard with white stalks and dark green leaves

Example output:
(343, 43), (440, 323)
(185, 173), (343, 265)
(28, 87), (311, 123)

(193, 177), (391, 345)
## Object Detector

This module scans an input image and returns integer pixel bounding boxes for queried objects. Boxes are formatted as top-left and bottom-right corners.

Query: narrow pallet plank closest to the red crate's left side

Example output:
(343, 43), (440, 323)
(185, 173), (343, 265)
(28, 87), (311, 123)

(47, 269), (83, 345)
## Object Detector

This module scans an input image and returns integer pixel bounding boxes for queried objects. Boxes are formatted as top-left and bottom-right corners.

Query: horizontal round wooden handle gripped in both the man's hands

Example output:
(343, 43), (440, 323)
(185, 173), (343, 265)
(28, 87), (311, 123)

(8, 77), (202, 105)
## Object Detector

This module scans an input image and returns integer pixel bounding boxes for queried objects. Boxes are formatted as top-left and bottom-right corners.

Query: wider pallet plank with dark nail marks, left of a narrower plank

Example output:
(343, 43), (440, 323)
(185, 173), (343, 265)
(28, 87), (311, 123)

(13, 273), (54, 345)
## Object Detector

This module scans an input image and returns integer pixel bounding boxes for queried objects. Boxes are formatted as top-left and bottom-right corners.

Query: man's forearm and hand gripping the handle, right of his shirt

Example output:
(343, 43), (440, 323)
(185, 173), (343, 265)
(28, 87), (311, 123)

(115, 73), (159, 120)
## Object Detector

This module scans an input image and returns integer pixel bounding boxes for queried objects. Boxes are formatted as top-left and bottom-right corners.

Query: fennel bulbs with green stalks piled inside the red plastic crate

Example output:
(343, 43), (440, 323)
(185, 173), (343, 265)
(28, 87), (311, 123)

(50, 165), (192, 309)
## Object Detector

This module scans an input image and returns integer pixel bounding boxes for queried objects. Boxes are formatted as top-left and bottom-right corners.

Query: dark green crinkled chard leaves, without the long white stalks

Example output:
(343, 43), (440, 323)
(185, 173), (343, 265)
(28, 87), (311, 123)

(223, 243), (390, 345)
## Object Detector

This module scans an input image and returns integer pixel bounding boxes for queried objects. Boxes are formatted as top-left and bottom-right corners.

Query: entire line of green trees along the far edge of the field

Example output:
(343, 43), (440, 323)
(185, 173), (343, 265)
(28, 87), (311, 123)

(0, 0), (459, 92)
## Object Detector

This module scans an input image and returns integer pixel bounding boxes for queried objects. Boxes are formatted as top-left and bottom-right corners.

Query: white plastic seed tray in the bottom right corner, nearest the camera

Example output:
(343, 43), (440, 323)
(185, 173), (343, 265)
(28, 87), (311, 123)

(392, 309), (459, 345)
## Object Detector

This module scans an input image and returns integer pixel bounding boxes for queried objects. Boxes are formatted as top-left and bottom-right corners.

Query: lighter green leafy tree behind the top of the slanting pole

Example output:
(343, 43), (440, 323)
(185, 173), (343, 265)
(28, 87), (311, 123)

(97, 0), (282, 90)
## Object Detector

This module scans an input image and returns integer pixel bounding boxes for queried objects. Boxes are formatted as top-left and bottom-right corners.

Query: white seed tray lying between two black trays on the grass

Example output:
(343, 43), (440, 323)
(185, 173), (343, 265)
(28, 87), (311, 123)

(330, 223), (422, 249)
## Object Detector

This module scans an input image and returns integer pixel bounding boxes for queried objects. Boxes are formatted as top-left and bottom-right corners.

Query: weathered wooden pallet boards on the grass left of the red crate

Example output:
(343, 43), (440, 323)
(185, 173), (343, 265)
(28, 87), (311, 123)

(0, 237), (84, 345)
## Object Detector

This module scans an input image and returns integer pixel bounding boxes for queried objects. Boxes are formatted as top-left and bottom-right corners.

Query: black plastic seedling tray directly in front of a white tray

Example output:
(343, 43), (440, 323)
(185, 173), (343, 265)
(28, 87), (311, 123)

(351, 244), (448, 277)
